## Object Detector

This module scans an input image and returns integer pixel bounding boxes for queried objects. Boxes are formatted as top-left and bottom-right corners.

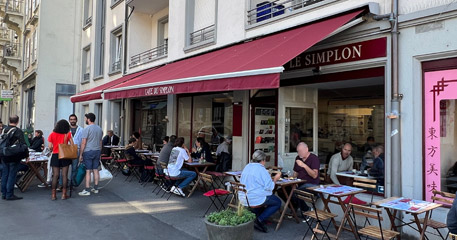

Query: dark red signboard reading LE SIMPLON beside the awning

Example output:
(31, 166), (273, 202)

(284, 38), (387, 70)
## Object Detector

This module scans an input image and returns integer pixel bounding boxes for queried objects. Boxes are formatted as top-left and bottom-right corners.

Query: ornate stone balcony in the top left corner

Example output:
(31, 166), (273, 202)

(0, 0), (24, 35)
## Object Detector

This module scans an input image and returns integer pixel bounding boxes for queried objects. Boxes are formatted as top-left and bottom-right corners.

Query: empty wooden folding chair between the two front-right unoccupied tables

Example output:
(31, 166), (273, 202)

(341, 203), (400, 240)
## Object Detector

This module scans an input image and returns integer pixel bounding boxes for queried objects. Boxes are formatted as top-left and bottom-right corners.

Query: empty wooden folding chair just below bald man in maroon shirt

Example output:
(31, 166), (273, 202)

(293, 189), (338, 239)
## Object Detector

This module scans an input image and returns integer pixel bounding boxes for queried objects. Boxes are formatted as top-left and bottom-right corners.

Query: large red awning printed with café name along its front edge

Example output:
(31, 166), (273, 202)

(103, 10), (363, 99)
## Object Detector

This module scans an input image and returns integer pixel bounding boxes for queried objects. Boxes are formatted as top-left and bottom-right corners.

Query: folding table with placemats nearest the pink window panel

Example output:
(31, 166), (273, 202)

(373, 197), (442, 239)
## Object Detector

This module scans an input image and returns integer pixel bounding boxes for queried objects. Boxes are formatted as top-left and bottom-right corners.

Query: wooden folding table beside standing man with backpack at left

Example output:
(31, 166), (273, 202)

(17, 155), (48, 192)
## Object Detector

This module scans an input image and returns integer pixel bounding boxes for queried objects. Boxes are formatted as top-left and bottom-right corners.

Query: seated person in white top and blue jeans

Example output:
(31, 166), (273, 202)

(167, 137), (197, 197)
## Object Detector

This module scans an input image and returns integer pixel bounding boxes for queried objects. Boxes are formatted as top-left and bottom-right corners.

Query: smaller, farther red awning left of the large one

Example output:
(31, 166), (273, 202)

(70, 68), (156, 103)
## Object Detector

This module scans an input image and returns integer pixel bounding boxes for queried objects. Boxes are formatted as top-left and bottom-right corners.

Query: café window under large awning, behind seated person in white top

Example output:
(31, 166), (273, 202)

(178, 92), (233, 151)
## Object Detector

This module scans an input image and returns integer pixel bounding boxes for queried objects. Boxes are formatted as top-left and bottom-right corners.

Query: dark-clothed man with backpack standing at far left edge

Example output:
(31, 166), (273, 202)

(2, 115), (25, 200)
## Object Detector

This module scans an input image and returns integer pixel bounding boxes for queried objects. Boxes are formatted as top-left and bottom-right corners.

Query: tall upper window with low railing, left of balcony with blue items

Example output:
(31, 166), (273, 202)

(186, 0), (217, 47)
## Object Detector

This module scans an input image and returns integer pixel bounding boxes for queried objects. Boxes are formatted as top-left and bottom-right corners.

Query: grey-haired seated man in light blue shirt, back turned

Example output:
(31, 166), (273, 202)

(238, 150), (281, 232)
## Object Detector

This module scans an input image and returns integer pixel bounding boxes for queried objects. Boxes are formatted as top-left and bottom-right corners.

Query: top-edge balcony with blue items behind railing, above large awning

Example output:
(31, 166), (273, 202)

(247, 0), (329, 26)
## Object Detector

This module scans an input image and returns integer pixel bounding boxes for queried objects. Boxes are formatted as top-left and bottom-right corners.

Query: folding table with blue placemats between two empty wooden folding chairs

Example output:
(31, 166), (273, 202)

(308, 184), (366, 239)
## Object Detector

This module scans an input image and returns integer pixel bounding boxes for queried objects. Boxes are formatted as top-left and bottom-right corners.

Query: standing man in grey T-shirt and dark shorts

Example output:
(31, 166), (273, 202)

(79, 113), (103, 196)
